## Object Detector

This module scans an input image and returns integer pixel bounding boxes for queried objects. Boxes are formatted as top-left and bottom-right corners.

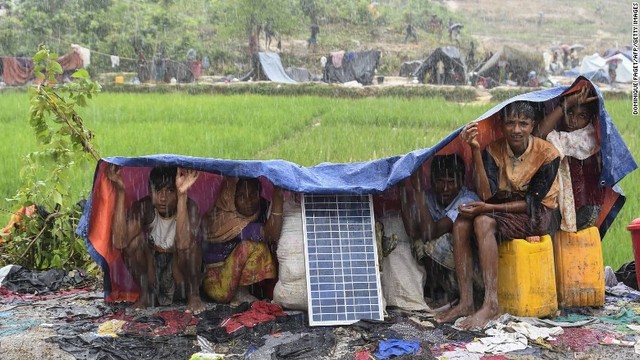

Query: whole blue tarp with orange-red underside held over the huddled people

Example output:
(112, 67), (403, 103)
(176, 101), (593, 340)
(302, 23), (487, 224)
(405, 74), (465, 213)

(77, 77), (637, 301)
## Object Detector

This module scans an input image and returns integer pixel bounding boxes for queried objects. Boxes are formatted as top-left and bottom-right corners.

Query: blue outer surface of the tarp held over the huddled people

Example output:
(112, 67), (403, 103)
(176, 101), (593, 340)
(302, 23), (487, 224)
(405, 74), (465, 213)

(77, 76), (638, 246)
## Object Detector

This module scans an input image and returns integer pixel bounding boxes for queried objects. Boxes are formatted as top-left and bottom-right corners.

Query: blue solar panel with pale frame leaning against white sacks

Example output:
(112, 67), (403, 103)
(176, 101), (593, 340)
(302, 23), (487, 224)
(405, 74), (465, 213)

(302, 194), (383, 326)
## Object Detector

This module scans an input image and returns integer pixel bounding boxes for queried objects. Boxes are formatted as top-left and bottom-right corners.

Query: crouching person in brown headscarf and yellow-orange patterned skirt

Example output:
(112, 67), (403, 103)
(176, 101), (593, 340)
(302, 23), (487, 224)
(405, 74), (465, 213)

(202, 177), (283, 305)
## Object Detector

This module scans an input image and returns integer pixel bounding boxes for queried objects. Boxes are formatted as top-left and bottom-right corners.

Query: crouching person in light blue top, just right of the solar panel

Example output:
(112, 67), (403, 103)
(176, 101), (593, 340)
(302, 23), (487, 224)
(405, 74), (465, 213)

(400, 154), (479, 304)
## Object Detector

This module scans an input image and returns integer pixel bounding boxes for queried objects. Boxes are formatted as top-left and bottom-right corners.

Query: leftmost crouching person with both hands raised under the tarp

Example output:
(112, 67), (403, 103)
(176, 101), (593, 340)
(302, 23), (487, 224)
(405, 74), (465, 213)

(107, 165), (205, 313)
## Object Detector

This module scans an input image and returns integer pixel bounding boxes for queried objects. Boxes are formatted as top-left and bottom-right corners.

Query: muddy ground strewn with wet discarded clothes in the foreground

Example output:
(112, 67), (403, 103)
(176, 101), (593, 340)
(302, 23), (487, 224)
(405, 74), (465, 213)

(0, 282), (640, 360)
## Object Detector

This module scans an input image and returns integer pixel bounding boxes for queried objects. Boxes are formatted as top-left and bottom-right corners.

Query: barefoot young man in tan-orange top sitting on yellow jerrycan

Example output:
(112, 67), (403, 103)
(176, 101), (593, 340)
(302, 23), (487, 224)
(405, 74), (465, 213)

(436, 101), (560, 329)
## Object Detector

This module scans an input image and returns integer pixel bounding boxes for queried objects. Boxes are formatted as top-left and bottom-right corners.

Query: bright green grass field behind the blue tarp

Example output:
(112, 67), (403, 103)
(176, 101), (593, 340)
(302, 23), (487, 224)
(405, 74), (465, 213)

(0, 92), (640, 268)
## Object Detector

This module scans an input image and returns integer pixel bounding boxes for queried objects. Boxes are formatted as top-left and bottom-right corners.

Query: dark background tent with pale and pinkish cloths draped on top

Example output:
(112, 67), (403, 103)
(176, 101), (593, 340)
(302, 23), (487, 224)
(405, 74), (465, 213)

(322, 50), (380, 85)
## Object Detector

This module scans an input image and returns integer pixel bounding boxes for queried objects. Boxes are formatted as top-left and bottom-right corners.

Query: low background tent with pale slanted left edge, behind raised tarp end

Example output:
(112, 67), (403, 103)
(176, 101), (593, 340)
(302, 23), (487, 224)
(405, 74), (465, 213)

(475, 45), (544, 85)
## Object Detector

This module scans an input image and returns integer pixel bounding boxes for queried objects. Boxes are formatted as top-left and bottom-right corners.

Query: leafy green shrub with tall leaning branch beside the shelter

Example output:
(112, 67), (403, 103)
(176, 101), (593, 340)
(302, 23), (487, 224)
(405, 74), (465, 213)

(0, 46), (101, 269)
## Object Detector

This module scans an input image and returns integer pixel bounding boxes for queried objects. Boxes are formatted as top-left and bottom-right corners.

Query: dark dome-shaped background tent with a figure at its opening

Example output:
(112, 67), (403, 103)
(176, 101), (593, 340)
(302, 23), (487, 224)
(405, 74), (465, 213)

(413, 46), (467, 85)
